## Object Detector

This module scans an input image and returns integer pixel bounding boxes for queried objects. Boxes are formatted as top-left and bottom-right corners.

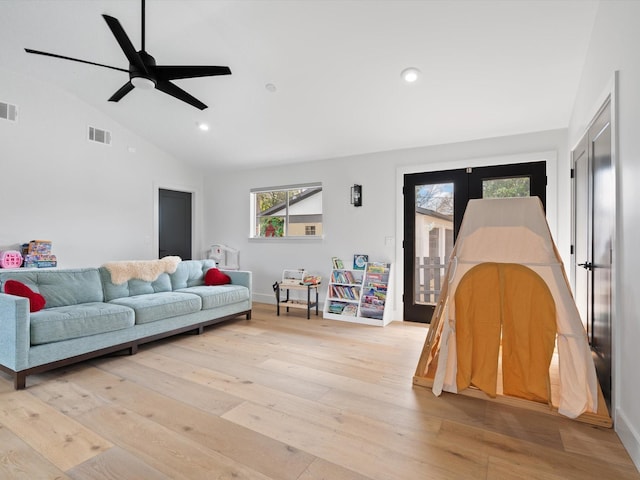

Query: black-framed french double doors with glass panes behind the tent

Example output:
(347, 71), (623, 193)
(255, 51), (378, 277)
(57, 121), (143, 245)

(403, 161), (547, 323)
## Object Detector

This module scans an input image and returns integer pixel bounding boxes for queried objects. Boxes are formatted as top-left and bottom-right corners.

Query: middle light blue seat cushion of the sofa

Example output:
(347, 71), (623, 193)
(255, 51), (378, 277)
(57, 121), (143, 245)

(109, 292), (202, 325)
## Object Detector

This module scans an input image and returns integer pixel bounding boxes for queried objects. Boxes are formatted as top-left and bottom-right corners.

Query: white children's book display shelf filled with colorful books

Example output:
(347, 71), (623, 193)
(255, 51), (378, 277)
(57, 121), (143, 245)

(323, 262), (391, 326)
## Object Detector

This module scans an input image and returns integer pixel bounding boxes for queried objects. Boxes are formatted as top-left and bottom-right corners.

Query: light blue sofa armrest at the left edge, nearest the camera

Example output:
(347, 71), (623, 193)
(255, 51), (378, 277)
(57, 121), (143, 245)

(0, 293), (31, 372)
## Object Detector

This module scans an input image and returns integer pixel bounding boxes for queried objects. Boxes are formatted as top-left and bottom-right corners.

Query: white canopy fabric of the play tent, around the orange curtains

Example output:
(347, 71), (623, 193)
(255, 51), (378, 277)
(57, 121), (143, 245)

(432, 197), (598, 418)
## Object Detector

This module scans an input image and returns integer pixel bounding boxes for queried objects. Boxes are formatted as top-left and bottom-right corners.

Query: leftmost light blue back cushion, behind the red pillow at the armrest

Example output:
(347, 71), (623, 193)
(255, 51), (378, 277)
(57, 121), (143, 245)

(0, 268), (104, 310)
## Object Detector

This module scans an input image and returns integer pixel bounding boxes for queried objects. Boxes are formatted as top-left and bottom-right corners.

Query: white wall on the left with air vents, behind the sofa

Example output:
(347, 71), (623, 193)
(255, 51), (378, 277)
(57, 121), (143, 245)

(0, 71), (202, 267)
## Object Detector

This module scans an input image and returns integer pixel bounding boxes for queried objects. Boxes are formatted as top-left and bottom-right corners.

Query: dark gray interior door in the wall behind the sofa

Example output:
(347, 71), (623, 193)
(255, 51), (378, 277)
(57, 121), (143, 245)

(158, 189), (192, 260)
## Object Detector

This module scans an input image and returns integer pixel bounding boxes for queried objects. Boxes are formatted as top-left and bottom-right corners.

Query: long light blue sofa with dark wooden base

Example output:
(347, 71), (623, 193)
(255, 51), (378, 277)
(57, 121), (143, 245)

(0, 260), (252, 389)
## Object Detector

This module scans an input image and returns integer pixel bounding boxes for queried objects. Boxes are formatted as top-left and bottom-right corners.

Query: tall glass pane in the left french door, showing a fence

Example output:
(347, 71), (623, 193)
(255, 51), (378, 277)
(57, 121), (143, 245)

(413, 183), (454, 305)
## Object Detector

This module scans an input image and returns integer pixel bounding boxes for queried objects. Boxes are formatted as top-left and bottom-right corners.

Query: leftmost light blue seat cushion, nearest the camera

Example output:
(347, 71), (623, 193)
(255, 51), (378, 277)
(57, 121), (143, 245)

(30, 302), (134, 345)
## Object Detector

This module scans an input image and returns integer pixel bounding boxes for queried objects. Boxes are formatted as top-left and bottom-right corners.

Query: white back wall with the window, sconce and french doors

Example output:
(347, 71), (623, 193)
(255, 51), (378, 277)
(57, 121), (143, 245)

(204, 130), (570, 319)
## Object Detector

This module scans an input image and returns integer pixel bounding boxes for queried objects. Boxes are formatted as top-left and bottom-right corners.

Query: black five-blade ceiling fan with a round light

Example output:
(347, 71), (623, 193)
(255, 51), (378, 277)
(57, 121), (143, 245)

(25, 0), (231, 110)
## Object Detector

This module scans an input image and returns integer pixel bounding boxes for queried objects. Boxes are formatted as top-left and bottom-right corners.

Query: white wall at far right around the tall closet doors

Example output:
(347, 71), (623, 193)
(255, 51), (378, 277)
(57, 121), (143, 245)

(569, 0), (640, 468)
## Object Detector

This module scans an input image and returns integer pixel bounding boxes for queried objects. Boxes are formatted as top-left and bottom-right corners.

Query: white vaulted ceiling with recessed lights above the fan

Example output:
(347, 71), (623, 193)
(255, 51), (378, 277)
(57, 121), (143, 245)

(0, 0), (598, 168)
